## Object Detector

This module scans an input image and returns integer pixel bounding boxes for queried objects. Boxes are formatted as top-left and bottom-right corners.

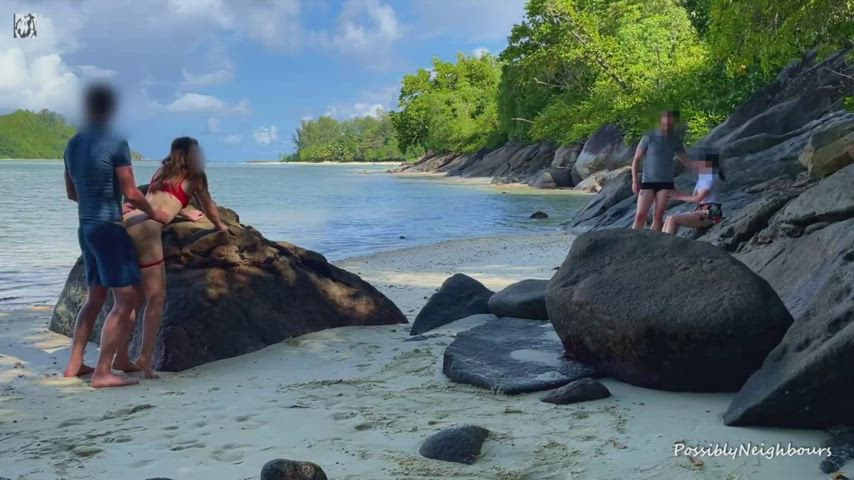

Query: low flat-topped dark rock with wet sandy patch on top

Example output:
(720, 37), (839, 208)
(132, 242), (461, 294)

(442, 318), (594, 395)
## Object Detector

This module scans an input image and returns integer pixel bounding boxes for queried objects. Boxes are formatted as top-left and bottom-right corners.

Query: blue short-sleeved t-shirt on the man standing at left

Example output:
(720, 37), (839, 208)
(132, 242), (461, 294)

(65, 128), (131, 223)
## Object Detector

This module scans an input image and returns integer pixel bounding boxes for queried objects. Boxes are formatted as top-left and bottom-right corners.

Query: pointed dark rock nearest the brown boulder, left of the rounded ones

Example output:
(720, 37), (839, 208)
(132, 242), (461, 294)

(409, 273), (494, 335)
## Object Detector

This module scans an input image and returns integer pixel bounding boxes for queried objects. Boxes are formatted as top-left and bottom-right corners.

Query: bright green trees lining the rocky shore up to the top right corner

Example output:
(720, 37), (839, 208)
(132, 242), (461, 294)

(295, 0), (854, 160)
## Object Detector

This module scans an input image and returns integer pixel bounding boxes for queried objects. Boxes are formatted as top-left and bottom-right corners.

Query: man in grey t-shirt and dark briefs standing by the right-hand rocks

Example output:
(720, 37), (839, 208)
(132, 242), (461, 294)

(632, 110), (688, 232)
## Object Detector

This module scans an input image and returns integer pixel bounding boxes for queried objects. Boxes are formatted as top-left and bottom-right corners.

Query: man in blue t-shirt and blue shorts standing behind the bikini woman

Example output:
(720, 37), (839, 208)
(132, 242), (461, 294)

(64, 85), (169, 387)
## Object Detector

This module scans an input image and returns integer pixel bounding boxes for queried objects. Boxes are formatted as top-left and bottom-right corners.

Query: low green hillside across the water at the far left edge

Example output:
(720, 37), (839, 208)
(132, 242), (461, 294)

(0, 110), (74, 158)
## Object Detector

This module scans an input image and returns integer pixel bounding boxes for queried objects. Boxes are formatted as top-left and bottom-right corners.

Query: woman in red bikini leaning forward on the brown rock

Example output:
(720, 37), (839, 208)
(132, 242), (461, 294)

(118, 137), (228, 378)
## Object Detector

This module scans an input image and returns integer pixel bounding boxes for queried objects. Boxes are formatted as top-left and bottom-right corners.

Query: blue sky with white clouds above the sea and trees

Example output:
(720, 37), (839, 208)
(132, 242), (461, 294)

(0, 0), (524, 161)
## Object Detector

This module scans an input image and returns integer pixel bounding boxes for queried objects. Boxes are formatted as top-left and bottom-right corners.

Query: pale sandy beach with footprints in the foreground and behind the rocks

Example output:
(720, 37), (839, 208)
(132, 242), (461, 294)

(0, 235), (826, 480)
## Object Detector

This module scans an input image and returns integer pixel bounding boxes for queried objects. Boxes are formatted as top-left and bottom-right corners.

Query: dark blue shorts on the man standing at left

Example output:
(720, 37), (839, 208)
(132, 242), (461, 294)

(77, 223), (141, 287)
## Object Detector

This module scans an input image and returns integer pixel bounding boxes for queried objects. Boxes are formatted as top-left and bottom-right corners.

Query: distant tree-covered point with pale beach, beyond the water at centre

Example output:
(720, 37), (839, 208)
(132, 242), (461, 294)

(280, 111), (423, 163)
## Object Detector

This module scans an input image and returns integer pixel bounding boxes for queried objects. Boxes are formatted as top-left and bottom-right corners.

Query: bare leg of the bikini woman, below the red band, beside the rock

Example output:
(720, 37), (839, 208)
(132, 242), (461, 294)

(134, 263), (166, 378)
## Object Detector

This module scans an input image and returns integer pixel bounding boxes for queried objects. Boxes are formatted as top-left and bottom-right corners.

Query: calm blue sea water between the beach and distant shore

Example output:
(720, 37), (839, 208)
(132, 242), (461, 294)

(0, 160), (589, 310)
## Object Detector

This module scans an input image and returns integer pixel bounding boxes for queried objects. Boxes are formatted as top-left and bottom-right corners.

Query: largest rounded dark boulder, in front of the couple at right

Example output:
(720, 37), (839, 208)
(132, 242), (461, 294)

(546, 230), (792, 391)
